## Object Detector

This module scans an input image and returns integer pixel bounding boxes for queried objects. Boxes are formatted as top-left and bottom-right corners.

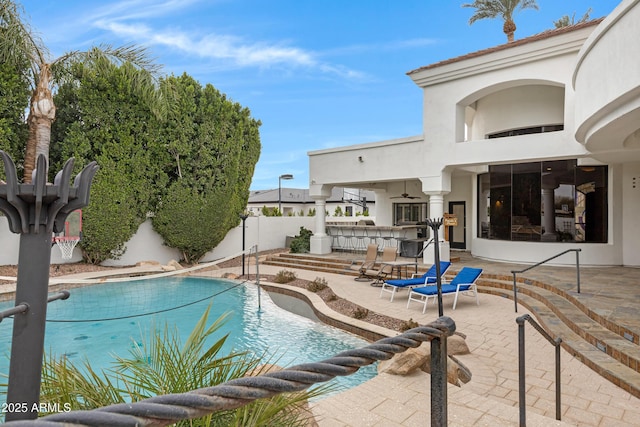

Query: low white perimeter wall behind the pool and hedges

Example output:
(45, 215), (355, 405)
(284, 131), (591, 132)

(0, 216), (315, 266)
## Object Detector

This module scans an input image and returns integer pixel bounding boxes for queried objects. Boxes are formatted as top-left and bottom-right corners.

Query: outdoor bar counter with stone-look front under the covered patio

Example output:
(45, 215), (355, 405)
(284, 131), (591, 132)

(327, 224), (424, 251)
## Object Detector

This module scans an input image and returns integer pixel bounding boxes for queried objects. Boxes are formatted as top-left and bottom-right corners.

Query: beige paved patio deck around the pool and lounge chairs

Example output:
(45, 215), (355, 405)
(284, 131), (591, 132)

(215, 253), (640, 427)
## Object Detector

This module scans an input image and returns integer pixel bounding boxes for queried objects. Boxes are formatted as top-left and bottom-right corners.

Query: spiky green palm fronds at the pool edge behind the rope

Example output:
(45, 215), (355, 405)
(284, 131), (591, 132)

(41, 307), (330, 427)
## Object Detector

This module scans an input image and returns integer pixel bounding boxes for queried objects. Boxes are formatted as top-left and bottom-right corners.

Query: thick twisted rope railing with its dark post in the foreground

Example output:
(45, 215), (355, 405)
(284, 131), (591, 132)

(5, 316), (456, 427)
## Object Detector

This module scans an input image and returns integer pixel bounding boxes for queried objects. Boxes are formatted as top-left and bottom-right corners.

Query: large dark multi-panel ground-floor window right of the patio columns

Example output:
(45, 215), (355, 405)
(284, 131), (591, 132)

(478, 160), (608, 243)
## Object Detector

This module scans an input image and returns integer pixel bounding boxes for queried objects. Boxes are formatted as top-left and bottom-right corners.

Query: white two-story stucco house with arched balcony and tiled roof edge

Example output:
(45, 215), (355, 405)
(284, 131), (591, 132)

(309, 0), (640, 266)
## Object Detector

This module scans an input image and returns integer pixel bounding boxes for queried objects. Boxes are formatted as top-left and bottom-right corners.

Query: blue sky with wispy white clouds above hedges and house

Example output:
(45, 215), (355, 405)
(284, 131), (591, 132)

(21, 0), (620, 190)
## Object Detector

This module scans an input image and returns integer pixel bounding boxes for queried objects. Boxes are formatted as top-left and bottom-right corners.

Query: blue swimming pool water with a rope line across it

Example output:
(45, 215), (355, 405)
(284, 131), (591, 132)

(0, 277), (376, 400)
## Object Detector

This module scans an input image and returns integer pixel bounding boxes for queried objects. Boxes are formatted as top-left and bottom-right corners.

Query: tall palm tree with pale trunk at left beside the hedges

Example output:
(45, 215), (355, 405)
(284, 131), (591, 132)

(0, 0), (160, 182)
